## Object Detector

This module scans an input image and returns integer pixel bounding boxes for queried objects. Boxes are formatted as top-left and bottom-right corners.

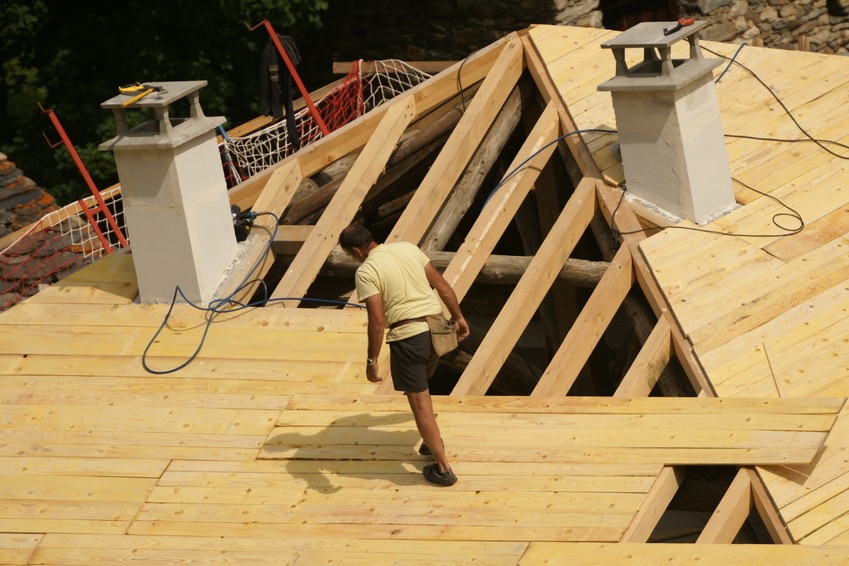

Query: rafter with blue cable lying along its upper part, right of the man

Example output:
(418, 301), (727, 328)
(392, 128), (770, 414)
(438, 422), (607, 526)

(443, 100), (559, 300)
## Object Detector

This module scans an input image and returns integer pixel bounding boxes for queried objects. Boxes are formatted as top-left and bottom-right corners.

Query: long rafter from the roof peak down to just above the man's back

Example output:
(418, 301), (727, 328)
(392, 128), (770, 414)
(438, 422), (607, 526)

(386, 36), (524, 244)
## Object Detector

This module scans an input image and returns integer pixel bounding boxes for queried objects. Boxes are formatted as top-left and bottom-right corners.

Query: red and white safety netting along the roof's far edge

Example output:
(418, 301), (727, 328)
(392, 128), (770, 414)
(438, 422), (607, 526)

(0, 60), (430, 311)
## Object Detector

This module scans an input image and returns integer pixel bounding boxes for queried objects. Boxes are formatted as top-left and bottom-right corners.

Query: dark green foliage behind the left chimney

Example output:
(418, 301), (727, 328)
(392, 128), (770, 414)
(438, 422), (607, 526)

(0, 0), (328, 204)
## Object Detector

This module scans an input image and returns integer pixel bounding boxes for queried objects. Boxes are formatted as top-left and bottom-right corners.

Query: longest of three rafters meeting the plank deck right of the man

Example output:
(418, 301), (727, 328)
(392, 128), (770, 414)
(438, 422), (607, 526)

(446, 181), (595, 395)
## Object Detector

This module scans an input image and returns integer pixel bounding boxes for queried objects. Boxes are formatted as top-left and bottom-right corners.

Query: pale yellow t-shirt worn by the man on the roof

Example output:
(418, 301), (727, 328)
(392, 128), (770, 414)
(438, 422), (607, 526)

(354, 242), (442, 342)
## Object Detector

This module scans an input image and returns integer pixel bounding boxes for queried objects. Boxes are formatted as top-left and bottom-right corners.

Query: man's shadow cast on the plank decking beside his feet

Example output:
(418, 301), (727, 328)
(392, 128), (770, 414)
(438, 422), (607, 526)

(260, 412), (424, 494)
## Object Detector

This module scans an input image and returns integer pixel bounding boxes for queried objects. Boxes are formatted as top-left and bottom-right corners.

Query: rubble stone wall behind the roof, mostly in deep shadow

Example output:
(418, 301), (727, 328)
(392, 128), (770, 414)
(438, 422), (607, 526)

(316, 0), (849, 72)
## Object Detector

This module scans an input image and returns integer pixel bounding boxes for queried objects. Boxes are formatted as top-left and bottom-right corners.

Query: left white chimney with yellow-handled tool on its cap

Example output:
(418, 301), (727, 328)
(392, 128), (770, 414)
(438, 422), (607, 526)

(100, 81), (238, 305)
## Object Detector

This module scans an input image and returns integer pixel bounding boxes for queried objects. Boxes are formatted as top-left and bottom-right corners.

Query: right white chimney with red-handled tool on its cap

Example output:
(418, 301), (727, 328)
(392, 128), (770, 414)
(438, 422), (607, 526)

(598, 21), (736, 224)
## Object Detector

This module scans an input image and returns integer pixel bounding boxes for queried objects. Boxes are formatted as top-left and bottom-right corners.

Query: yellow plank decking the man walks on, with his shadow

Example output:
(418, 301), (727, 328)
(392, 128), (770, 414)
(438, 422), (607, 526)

(0, 255), (842, 564)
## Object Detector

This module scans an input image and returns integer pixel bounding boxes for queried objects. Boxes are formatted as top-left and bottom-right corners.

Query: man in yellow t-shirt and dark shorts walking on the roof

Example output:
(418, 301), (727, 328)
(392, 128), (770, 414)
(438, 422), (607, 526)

(339, 224), (469, 486)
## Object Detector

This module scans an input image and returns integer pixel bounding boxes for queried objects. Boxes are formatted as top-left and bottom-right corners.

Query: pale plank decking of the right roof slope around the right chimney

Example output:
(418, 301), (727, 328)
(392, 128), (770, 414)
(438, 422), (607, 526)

(531, 22), (849, 545)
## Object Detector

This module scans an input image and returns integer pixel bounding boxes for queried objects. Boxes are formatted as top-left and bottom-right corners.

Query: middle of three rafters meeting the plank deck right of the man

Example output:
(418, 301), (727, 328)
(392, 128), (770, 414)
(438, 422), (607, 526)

(531, 245), (634, 397)
